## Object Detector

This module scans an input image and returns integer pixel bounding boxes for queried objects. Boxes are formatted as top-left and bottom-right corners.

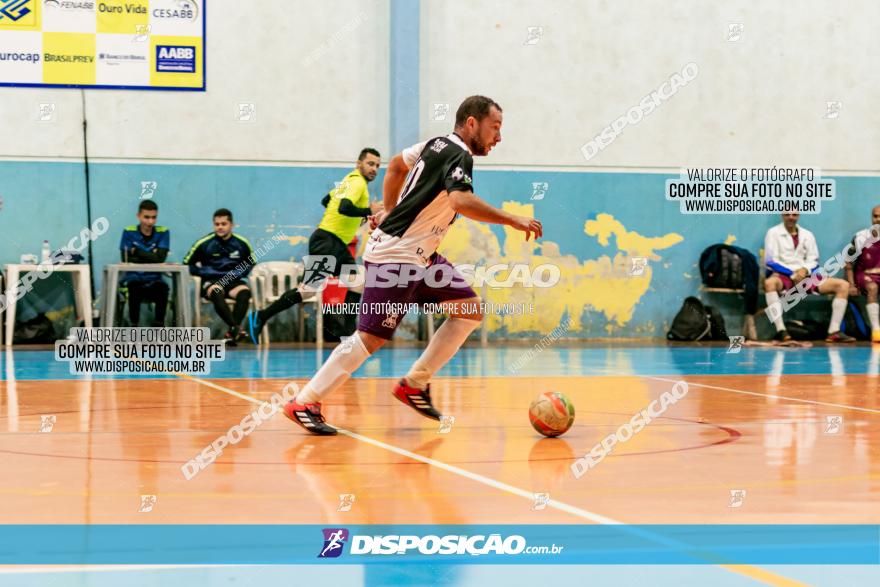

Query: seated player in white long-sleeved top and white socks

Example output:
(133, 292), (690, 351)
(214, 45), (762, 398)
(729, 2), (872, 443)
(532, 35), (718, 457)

(764, 213), (856, 343)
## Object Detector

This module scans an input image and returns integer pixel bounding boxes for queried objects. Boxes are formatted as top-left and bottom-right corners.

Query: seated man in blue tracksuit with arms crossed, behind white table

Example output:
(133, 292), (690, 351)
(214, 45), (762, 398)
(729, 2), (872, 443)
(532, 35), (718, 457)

(119, 200), (171, 326)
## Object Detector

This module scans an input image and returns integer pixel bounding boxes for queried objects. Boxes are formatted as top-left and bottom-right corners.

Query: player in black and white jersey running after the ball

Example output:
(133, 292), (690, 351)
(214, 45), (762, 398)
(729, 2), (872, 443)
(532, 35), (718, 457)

(284, 96), (542, 435)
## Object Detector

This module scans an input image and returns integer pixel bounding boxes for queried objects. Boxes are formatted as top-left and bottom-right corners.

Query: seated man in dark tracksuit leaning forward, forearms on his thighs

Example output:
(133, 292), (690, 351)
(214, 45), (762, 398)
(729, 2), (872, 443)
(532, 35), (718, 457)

(183, 208), (256, 346)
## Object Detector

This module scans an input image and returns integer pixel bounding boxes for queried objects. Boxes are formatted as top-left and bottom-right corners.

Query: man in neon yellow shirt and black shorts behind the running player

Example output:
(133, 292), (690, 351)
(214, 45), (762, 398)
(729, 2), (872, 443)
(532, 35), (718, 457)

(247, 147), (383, 344)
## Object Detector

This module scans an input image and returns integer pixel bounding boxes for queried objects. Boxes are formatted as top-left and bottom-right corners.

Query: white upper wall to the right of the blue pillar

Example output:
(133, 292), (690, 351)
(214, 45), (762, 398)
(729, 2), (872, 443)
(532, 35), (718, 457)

(421, 0), (880, 171)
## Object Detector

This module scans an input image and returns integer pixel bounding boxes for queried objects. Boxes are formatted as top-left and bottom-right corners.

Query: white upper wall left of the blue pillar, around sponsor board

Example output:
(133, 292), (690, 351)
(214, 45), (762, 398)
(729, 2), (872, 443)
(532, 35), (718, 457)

(0, 0), (389, 163)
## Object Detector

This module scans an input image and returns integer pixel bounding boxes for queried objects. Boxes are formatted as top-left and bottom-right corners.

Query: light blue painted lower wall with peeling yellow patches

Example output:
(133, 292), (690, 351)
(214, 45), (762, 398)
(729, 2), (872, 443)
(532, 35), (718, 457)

(0, 162), (880, 338)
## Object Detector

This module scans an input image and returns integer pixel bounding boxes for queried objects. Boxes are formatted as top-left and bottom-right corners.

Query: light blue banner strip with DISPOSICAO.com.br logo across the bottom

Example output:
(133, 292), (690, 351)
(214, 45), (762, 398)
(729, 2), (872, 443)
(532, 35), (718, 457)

(0, 524), (880, 565)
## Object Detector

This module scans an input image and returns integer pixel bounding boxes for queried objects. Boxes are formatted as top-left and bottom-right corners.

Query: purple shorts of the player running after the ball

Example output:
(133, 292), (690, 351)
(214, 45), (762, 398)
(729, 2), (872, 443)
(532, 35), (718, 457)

(358, 253), (477, 340)
